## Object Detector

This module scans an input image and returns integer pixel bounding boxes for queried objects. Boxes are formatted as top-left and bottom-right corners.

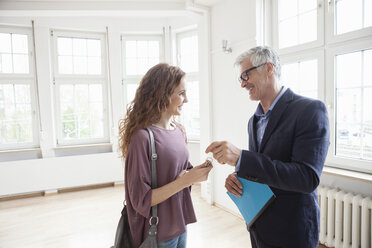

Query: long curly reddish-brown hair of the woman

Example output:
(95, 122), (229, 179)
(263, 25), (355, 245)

(119, 63), (185, 158)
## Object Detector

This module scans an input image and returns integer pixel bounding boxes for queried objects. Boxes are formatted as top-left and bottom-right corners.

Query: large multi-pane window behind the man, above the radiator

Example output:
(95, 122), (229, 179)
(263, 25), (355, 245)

(272, 0), (372, 173)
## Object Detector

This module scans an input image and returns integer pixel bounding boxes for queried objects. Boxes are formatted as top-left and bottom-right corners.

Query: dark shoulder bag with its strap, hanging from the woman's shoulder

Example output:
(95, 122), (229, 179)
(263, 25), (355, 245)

(111, 127), (159, 248)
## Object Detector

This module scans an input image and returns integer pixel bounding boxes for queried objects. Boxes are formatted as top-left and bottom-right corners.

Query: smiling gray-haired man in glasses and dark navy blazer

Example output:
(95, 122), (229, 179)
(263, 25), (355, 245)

(206, 47), (329, 248)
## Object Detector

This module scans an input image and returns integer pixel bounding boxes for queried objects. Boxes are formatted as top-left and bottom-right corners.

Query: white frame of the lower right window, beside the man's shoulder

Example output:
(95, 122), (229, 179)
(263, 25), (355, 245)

(326, 39), (372, 173)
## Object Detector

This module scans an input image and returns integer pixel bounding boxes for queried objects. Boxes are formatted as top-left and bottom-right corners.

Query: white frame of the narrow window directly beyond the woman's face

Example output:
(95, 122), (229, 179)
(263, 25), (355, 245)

(176, 30), (200, 142)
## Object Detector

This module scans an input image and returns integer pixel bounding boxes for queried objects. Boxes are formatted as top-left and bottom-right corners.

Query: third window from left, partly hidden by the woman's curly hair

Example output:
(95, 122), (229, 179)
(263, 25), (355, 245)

(121, 36), (164, 105)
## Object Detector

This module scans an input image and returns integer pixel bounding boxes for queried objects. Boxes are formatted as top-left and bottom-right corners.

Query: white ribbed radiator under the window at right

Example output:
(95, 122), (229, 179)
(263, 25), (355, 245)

(318, 186), (372, 248)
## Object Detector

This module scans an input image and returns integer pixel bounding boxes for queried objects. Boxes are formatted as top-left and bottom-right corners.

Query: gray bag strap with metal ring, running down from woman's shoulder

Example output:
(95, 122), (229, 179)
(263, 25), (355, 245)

(146, 127), (159, 232)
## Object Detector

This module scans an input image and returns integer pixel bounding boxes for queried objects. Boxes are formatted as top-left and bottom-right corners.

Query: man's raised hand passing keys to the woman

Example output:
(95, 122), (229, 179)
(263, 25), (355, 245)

(205, 141), (242, 166)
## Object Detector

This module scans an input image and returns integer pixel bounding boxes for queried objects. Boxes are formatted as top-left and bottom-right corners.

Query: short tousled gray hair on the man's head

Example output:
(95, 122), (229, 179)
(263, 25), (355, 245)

(235, 46), (281, 79)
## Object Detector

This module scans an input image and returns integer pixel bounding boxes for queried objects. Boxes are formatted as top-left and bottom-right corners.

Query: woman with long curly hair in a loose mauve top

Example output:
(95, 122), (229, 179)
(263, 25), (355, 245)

(119, 63), (212, 248)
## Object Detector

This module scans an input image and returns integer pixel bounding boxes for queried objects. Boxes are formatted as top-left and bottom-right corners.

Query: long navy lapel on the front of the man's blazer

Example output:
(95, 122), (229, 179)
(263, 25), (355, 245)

(260, 88), (294, 152)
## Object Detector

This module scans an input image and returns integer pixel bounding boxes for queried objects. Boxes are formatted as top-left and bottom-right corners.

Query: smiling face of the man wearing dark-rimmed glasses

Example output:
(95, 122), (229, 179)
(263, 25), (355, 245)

(240, 58), (266, 101)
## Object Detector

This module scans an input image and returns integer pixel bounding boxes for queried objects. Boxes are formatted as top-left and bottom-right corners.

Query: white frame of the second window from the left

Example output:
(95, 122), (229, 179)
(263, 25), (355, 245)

(51, 30), (110, 146)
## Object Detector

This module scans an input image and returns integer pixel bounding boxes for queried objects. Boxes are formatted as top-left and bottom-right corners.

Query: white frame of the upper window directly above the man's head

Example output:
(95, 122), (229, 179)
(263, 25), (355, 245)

(272, 0), (324, 54)
